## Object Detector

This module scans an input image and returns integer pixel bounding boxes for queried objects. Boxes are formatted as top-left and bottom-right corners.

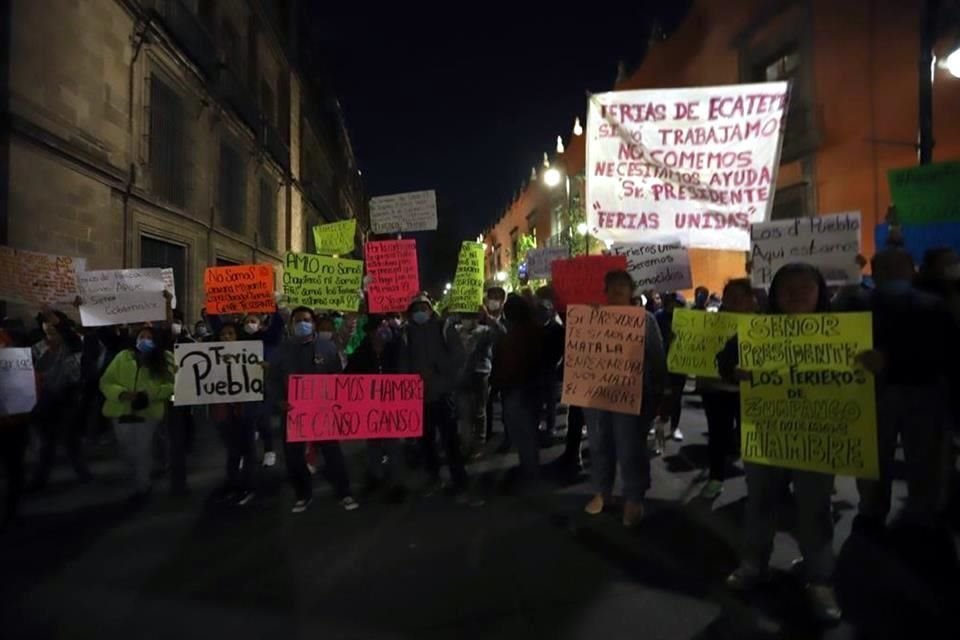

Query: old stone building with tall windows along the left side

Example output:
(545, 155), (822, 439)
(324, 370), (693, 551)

(0, 0), (369, 319)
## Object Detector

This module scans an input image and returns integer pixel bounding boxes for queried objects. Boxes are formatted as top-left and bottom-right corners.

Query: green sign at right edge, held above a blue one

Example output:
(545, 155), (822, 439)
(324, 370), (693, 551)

(887, 161), (960, 224)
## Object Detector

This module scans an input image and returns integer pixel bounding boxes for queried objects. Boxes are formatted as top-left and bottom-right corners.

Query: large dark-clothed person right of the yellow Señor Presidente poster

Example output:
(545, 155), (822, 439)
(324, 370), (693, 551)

(840, 248), (960, 532)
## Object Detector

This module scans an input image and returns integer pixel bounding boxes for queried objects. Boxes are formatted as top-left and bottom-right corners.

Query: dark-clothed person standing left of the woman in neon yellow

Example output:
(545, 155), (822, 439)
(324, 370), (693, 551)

(31, 309), (91, 490)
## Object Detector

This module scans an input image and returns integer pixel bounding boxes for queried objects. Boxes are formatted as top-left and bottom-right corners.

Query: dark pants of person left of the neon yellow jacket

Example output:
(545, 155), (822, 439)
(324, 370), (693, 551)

(33, 394), (90, 487)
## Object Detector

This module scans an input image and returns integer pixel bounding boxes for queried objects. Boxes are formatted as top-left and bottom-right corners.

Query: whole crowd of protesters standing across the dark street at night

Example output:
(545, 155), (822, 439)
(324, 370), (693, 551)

(0, 241), (960, 621)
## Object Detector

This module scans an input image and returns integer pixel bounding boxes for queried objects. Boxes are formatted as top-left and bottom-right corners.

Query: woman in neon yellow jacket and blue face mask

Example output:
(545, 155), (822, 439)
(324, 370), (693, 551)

(100, 327), (175, 502)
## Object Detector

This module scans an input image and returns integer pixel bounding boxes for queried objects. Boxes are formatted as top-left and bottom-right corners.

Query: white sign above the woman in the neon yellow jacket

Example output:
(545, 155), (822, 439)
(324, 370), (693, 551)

(77, 269), (167, 327)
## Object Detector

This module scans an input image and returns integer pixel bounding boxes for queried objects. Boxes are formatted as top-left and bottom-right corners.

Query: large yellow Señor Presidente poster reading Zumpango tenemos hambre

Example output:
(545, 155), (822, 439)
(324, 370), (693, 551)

(737, 313), (879, 478)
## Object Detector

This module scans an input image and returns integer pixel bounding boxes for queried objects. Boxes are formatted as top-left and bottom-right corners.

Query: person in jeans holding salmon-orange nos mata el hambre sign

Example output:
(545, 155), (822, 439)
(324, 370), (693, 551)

(583, 271), (667, 527)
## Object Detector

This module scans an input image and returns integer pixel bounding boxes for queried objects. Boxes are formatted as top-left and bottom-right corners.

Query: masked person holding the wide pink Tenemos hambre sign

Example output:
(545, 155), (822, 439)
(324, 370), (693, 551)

(267, 307), (360, 513)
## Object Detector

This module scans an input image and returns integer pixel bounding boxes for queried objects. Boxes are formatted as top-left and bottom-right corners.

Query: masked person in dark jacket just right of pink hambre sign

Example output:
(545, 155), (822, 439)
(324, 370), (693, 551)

(398, 294), (472, 500)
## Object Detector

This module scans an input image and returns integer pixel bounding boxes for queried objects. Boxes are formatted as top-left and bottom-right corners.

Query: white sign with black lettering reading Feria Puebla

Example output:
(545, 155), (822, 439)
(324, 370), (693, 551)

(173, 340), (263, 406)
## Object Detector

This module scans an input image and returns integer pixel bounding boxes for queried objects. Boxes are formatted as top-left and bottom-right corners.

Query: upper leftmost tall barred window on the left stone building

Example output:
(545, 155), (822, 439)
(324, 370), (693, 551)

(150, 75), (187, 207)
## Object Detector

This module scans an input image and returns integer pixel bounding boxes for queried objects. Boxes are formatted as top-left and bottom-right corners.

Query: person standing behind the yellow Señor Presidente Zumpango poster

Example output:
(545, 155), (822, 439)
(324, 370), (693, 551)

(720, 263), (841, 621)
